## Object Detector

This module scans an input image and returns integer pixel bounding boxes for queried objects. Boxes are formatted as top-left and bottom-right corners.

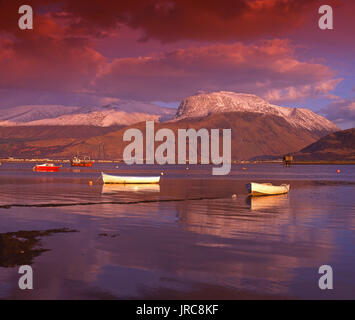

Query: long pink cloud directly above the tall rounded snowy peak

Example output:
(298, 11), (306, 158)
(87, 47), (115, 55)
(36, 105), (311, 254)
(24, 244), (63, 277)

(94, 39), (339, 101)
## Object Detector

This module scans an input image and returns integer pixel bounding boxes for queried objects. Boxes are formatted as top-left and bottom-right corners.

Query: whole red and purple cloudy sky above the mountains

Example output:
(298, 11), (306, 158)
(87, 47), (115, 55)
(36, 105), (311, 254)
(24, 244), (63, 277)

(0, 0), (355, 129)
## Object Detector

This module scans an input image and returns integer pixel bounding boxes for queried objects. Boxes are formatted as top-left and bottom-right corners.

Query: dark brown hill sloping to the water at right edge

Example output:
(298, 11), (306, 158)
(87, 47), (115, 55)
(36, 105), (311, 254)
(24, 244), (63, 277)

(294, 128), (355, 160)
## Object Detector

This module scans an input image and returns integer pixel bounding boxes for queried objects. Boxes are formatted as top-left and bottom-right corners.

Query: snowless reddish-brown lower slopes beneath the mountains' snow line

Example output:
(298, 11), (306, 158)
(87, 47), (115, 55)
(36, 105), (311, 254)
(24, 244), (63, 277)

(0, 112), (340, 160)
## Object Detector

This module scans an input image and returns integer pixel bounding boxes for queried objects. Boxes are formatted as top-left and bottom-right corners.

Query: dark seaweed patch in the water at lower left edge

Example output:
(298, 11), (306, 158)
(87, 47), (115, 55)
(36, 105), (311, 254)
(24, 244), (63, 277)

(0, 228), (77, 268)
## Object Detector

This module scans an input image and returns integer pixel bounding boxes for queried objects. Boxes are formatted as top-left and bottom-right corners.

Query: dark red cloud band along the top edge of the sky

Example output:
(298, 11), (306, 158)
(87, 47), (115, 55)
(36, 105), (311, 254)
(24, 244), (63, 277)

(0, 0), (337, 42)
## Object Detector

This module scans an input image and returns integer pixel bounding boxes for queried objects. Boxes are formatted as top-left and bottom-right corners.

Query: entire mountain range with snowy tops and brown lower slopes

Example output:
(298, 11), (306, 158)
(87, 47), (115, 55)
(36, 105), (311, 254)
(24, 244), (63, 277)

(0, 92), (339, 160)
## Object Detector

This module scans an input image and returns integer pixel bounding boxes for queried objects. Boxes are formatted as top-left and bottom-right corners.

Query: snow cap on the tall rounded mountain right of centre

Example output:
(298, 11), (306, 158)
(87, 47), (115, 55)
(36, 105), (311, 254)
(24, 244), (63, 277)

(175, 91), (340, 132)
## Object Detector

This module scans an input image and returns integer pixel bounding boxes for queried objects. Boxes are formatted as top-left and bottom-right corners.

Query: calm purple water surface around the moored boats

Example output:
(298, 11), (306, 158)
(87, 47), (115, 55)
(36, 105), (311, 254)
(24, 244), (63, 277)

(0, 164), (355, 299)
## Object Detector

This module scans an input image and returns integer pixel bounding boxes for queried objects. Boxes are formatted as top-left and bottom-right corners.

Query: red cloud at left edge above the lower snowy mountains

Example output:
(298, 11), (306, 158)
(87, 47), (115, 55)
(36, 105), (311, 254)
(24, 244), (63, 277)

(0, 37), (106, 92)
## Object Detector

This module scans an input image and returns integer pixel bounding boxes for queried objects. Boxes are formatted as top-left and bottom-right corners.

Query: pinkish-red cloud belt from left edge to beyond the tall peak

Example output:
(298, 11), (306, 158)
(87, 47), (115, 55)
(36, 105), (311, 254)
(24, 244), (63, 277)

(0, 27), (339, 101)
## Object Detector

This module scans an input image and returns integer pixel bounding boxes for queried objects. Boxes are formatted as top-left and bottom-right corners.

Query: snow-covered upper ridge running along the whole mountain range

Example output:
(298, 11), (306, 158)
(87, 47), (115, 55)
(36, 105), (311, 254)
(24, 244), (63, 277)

(0, 91), (340, 135)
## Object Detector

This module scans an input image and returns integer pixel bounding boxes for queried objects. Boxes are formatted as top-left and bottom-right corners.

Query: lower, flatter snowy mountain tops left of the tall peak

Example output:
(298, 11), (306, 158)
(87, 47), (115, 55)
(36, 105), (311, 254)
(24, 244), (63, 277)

(0, 100), (175, 127)
